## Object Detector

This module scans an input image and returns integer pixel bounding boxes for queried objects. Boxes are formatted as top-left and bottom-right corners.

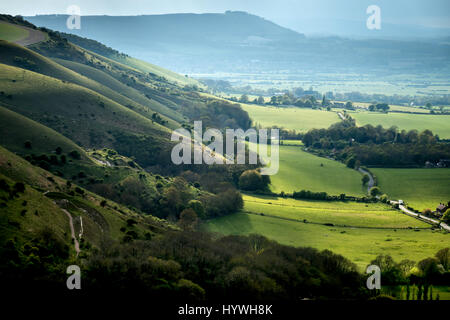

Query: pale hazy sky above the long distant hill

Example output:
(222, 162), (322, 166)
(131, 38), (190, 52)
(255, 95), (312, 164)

(0, 0), (450, 28)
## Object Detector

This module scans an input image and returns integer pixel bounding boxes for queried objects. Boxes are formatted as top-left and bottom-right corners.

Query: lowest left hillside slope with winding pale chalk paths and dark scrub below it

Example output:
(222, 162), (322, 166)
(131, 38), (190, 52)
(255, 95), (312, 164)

(0, 147), (172, 253)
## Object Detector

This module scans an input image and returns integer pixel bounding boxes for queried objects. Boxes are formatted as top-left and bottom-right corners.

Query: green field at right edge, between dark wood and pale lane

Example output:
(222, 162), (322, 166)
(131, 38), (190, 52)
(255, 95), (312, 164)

(371, 168), (450, 211)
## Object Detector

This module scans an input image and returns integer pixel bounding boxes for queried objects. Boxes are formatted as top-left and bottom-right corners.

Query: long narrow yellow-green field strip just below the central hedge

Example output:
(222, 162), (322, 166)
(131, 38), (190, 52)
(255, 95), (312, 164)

(243, 195), (429, 228)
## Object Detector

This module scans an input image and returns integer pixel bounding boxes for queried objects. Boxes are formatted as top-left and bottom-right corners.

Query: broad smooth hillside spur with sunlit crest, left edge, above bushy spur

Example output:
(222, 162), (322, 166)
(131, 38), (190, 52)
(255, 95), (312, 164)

(0, 65), (171, 166)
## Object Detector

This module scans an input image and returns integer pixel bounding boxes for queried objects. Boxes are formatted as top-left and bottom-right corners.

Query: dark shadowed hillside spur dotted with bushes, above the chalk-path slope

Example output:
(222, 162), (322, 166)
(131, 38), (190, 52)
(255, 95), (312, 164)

(0, 107), (190, 218)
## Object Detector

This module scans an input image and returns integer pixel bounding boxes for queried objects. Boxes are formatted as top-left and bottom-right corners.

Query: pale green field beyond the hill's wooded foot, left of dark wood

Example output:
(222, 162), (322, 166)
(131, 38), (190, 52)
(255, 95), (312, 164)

(241, 104), (339, 132)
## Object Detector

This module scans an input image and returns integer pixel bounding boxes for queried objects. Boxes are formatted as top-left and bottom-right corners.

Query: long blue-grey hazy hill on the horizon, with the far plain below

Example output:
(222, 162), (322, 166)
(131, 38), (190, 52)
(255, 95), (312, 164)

(26, 12), (450, 74)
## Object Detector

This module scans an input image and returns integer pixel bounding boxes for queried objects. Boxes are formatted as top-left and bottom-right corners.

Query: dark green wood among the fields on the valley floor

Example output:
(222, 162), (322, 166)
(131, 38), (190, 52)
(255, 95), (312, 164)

(303, 121), (450, 167)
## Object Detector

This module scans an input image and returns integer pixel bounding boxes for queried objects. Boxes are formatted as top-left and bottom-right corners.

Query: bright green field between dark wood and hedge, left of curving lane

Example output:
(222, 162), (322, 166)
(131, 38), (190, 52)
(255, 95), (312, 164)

(270, 146), (365, 196)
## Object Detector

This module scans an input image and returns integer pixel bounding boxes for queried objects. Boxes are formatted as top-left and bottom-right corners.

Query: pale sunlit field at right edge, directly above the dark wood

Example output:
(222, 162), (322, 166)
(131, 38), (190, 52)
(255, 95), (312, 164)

(351, 112), (450, 139)
